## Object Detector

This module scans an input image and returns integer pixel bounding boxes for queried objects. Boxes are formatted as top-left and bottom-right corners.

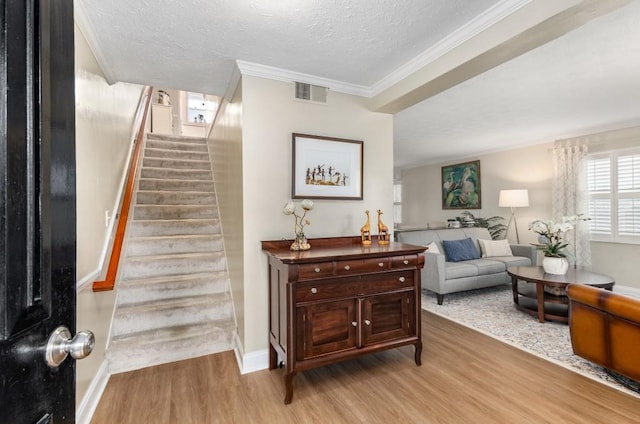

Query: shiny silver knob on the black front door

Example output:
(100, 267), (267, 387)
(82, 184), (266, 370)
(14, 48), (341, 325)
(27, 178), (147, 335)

(45, 326), (96, 368)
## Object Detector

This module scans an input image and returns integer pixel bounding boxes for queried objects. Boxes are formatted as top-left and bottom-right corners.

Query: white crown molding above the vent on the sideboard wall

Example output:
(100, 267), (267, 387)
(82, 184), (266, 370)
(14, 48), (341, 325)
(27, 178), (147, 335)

(236, 60), (372, 97)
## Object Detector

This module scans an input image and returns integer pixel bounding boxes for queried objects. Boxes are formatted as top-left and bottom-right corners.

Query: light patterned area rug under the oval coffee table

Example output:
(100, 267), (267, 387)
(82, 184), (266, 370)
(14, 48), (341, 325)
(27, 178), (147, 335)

(422, 285), (640, 398)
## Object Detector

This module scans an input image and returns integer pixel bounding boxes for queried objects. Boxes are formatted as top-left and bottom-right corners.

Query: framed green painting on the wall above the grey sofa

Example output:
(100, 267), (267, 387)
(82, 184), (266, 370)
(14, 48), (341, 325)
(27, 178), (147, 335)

(442, 160), (482, 209)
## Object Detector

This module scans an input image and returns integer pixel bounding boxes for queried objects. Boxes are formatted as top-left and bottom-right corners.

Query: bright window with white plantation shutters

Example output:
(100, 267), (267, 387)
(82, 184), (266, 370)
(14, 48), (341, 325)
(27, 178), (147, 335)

(587, 149), (640, 243)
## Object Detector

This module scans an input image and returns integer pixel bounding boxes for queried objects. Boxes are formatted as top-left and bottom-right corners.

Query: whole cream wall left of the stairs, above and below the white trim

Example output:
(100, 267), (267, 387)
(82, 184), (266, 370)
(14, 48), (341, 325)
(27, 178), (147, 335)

(75, 20), (143, 404)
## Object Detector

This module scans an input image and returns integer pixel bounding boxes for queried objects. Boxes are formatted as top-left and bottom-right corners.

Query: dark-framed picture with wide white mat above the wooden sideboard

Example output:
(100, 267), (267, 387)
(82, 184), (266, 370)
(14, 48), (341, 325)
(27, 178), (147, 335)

(291, 133), (363, 200)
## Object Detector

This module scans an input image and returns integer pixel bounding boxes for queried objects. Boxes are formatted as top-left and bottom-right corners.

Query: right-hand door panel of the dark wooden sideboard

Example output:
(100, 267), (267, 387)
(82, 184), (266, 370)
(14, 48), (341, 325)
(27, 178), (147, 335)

(362, 290), (416, 346)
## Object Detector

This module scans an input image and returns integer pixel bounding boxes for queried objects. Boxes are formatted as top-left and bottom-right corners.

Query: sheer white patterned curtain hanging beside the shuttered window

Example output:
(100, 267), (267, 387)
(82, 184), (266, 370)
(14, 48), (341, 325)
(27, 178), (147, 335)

(552, 140), (591, 266)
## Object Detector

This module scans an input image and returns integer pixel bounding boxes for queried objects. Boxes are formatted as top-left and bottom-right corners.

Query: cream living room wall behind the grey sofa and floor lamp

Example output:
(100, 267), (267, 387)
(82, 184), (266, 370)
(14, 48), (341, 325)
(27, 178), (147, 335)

(402, 143), (553, 247)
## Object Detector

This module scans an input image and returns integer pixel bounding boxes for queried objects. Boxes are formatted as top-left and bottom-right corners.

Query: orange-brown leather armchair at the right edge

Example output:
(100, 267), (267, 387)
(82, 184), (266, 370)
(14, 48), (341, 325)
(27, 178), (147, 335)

(567, 284), (640, 381)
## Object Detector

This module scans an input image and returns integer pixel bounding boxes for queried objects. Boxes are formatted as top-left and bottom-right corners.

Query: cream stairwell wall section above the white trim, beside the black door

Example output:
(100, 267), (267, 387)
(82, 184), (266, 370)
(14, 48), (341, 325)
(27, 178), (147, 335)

(75, 22), (143, 280)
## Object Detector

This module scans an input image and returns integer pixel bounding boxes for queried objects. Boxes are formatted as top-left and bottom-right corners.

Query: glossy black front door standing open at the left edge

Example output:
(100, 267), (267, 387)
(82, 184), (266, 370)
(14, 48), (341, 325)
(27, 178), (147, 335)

(0, 0), (76, 424)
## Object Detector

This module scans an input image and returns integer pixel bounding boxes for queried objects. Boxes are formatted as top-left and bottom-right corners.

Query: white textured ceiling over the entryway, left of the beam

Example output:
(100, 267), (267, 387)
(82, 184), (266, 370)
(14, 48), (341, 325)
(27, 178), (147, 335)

(79, 0), (498, 95)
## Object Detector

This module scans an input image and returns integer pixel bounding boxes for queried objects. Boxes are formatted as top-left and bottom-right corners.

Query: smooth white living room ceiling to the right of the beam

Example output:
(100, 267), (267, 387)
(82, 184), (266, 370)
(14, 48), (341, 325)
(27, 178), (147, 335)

(394, 1), (640, 167)
